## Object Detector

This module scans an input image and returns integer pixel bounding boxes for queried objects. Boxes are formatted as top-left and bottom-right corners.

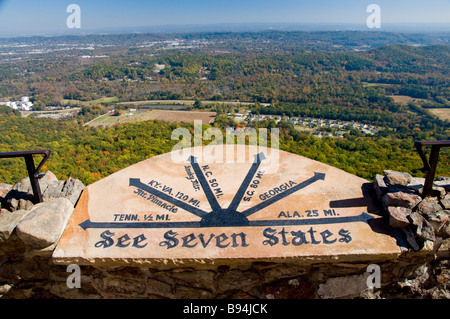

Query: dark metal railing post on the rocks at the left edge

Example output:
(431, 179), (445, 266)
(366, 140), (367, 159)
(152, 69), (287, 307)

(0, 150), (51, 203)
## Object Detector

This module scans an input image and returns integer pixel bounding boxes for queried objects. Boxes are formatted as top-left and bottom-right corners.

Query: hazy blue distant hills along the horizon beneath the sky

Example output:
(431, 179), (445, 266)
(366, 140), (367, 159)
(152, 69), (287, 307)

(0, 27), (450, 53)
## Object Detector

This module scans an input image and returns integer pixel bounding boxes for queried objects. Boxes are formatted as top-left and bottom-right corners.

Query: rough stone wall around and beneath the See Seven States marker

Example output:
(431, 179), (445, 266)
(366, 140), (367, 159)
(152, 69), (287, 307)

(0, 171), (450, 299)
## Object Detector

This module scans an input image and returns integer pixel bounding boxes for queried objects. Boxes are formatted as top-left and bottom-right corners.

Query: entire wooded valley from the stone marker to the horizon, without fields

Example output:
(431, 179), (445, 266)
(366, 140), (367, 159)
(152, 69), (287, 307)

(0, 32), (450, 188)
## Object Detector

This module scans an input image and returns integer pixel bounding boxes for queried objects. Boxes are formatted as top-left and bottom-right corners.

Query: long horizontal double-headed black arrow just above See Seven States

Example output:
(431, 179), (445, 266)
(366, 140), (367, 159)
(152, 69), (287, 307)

(79, 213), (373, 230)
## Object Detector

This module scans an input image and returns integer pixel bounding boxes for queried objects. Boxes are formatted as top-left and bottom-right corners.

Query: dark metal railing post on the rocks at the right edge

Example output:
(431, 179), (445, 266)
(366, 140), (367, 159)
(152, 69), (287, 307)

(414, 140), (450, 198)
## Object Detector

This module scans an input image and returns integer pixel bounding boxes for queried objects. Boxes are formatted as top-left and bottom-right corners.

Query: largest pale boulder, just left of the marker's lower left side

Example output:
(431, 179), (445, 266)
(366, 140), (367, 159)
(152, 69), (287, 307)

(16, 198), (74, 249)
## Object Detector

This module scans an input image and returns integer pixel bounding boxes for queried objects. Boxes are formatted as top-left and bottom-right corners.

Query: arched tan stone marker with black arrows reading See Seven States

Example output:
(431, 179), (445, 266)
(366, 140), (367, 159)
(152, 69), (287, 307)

(53, 145), (400, 267)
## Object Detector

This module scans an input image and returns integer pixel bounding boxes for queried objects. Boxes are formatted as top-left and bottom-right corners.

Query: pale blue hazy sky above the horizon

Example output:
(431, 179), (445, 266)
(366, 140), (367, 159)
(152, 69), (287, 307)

(0, 0), (450, 36)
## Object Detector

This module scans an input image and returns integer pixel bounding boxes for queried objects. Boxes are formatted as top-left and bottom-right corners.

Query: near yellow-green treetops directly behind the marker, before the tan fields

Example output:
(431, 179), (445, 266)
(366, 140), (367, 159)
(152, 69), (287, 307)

(0, 109), (450, 184)
